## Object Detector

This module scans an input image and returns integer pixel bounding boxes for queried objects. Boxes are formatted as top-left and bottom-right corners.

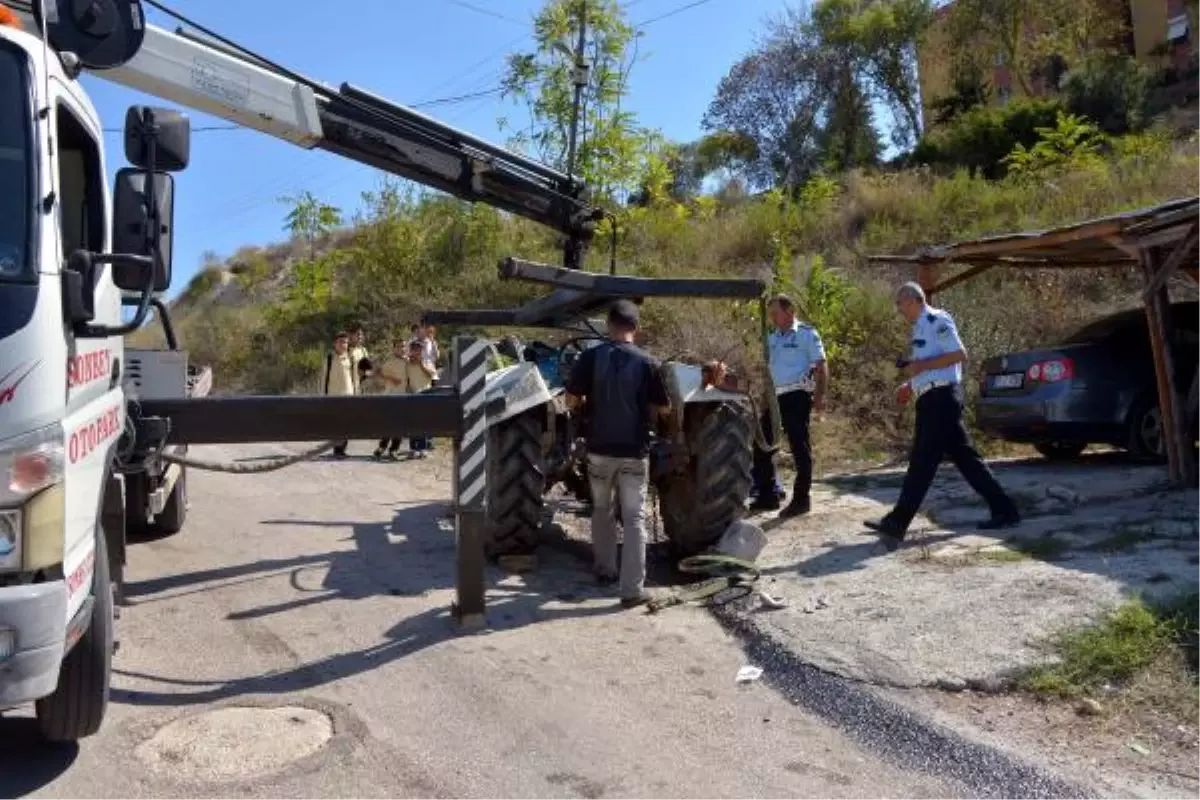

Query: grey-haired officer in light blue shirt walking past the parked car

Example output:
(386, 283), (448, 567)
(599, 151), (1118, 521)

(866, 283), (1021, 551)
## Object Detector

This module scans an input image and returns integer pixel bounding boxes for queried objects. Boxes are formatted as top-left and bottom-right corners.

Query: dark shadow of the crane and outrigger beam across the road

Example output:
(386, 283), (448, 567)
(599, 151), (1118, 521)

(113, 503), (619, 706)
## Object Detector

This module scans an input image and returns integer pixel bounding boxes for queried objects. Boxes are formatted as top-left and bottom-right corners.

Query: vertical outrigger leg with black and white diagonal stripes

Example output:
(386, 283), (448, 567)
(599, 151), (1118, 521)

(454, 336), (488, 628)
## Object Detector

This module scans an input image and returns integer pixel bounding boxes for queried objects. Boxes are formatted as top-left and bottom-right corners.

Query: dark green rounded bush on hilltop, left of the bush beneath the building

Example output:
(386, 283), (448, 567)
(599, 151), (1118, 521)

(913, 98), (1062, 180)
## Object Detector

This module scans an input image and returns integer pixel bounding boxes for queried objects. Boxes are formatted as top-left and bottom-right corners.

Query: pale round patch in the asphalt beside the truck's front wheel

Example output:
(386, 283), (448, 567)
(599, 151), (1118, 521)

(134, 706), (334, 781)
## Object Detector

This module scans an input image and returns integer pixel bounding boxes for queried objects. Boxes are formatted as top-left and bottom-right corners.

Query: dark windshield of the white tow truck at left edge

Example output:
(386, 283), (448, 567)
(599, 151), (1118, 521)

(0, 42), (35, 281)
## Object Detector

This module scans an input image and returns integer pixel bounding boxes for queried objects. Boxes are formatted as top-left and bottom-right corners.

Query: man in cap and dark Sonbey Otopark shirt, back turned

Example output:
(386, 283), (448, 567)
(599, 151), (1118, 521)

(566, 300), (671, 608)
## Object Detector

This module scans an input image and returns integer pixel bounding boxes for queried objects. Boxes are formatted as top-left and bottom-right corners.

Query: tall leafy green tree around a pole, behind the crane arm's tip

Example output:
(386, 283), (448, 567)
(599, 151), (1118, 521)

(499, 0), (646, 199)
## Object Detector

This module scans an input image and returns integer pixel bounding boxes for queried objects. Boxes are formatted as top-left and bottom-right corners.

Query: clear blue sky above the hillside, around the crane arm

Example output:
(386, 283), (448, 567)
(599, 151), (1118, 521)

(75, 0), (787, 295)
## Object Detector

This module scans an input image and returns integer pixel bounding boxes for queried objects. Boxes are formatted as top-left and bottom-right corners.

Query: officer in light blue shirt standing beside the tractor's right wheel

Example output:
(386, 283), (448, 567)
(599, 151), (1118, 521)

(751, 294), (829, 517)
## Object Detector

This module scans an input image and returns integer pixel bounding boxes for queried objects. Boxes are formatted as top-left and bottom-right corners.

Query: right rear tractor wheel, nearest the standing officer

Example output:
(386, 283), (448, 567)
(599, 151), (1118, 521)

(658, 403), (754, 558)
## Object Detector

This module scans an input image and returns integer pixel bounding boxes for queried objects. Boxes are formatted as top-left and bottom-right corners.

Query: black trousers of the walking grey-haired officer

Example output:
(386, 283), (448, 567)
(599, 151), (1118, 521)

(883, 384), (1016, 535)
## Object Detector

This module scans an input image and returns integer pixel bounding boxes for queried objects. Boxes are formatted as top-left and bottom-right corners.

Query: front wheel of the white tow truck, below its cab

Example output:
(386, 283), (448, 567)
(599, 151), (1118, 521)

(36, 533), (114, 742)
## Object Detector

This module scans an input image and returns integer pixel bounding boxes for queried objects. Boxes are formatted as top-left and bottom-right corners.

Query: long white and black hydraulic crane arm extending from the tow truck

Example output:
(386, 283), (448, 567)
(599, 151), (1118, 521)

(11, 0), (604, 267)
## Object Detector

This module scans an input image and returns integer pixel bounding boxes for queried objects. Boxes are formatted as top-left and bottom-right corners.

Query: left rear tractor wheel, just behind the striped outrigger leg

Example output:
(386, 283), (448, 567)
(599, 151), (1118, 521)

(486, 408), (546, 558)
